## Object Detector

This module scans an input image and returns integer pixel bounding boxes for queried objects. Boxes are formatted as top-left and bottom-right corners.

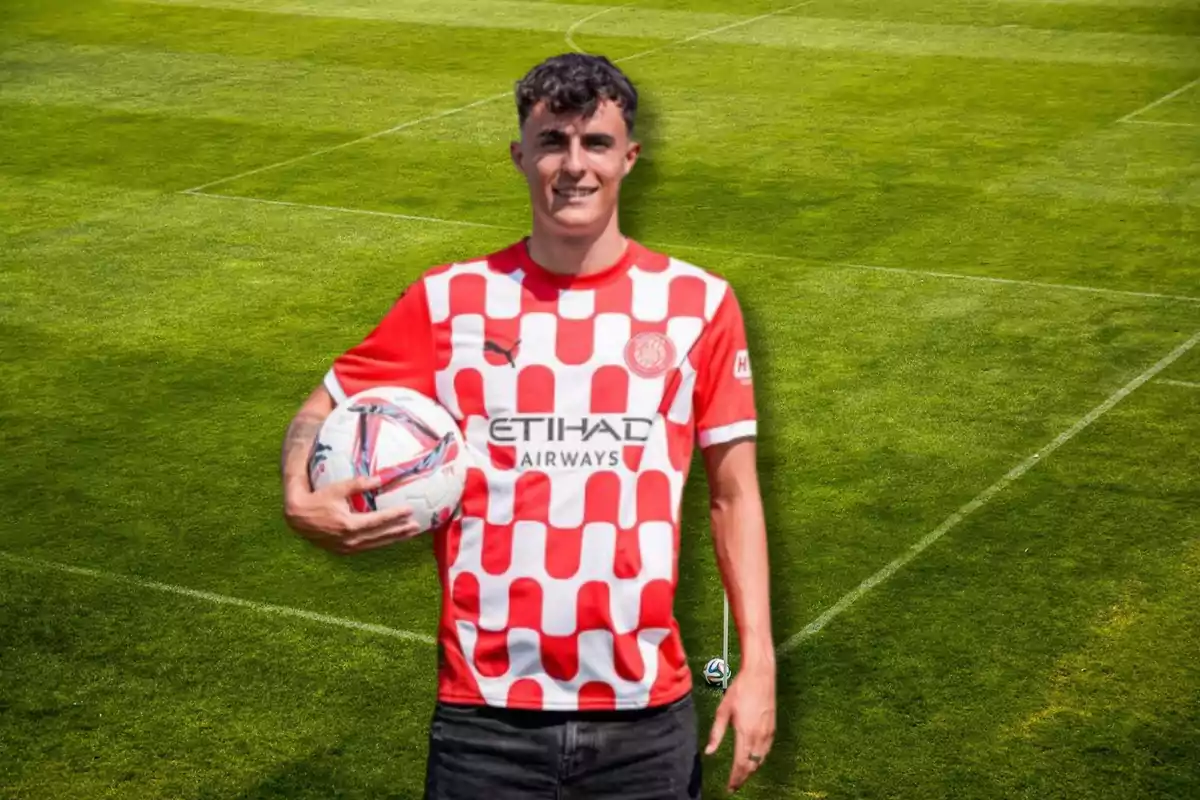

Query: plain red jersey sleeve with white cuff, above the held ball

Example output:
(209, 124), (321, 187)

(324, 281), (436, 403)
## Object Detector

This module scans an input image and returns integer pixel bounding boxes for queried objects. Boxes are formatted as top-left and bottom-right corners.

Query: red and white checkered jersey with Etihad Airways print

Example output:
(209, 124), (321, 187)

(325, 241), (756, 710)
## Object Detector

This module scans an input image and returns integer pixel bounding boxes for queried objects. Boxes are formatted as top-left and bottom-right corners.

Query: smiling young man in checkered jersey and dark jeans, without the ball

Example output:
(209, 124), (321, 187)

(283, 54), (775, 800)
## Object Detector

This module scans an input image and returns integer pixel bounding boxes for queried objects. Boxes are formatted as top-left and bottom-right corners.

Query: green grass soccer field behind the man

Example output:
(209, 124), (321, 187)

(0, 0), (1200, 800)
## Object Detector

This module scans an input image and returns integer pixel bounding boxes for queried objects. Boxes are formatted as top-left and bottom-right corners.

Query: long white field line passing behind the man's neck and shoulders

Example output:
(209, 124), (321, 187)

(182, 190), (1200, 303)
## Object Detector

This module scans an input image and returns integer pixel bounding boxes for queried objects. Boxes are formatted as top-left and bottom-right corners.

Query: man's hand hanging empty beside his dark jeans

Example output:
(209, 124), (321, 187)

(704, 669), (775, 794)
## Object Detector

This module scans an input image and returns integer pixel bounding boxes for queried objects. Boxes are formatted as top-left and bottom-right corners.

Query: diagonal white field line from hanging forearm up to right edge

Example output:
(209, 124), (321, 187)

(778, 331), (1200, 654)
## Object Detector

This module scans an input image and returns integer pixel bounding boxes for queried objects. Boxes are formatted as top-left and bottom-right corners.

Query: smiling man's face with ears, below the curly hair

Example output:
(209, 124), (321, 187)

(510, 100), (641, 235)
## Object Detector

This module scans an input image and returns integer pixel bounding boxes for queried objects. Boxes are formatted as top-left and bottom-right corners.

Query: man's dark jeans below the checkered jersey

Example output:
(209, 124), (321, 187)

(425, 696), (700, 800)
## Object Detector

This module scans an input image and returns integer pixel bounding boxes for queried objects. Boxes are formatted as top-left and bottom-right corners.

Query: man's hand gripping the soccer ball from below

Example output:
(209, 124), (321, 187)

(283, 476), (421, 555)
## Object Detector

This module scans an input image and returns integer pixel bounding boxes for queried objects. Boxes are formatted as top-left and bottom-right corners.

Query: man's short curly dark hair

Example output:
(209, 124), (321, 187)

(516, 53), (637, 134)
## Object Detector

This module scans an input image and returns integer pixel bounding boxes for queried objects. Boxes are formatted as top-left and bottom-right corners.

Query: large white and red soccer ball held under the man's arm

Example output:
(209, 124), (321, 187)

(308, 386), (469, 531)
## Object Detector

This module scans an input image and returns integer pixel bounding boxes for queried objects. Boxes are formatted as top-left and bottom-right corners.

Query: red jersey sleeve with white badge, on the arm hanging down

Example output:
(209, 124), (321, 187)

(694, 288), (758, 447)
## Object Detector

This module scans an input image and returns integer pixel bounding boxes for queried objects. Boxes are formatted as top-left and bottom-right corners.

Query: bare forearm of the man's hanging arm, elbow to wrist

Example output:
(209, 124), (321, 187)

(712, 479), (775, 670)
